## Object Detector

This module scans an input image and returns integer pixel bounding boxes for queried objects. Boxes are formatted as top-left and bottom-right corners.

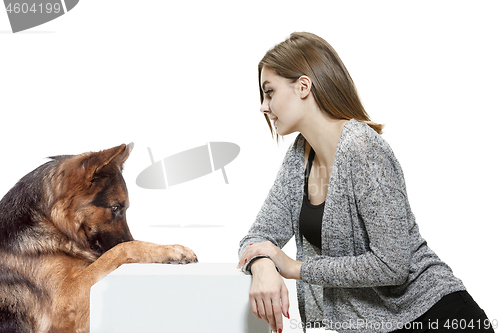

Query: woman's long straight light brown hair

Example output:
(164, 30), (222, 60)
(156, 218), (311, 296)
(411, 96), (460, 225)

(259, 32), (383, 137)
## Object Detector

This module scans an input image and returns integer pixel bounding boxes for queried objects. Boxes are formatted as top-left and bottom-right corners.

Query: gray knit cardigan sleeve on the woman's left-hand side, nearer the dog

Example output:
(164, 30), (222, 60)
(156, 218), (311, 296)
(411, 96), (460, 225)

(238, 146), (293, 264)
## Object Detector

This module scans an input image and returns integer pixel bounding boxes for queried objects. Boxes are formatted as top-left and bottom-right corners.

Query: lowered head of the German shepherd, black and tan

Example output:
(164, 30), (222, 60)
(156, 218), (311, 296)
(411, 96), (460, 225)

(48, 144), (133, 256)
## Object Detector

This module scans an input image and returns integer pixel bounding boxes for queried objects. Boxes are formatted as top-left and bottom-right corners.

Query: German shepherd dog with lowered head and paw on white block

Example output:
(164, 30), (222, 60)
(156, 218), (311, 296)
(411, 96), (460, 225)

(0, 144), (197, 333)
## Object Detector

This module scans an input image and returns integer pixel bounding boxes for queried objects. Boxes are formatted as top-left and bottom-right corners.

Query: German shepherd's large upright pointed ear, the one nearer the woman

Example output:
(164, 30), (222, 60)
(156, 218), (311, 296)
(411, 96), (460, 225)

(82, 143), (134, 182)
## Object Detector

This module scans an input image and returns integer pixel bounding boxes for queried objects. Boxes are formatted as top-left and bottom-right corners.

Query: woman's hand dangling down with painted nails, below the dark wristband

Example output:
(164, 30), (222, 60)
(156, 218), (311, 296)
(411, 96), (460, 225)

(250, 258), (290, 333)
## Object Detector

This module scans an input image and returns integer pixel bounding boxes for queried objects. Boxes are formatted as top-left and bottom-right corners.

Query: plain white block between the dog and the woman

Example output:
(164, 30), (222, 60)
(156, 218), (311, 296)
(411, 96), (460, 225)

(90, 263), (270, 333)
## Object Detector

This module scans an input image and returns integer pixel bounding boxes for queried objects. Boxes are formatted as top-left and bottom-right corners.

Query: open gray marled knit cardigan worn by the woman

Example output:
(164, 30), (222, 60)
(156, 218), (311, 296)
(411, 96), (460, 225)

(239, 119), (465, 332)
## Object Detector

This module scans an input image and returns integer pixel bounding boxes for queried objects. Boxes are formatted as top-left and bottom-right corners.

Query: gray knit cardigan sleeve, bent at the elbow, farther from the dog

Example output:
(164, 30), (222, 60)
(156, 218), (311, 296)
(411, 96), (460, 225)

(301, 126), (412, 288)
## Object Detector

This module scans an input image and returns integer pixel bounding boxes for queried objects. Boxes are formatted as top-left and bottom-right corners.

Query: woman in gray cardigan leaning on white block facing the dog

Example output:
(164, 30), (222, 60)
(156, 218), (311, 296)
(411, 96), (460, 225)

(238, 33), (493, 332)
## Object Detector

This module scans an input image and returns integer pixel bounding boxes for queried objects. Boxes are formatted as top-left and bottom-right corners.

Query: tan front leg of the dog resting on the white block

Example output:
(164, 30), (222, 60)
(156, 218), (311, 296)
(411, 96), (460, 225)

(53, 241), (198, 332)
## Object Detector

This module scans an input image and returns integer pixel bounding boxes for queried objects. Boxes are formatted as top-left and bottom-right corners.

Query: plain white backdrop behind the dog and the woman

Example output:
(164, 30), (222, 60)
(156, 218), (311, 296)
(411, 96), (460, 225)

(0, 0), (500, 332)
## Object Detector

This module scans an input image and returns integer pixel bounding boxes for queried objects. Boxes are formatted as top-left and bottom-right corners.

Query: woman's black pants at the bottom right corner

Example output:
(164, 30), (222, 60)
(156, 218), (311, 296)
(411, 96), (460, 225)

(394, 291), (498, 333)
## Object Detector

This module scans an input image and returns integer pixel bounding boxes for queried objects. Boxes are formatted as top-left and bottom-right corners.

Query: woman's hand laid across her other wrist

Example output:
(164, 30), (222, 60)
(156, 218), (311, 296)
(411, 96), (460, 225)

(238, 241), (302, 280)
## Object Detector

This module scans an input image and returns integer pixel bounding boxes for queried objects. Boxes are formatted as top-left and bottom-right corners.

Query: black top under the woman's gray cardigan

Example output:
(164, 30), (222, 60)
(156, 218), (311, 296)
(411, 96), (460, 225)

(299, 147), (325, 249)
